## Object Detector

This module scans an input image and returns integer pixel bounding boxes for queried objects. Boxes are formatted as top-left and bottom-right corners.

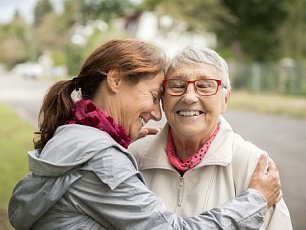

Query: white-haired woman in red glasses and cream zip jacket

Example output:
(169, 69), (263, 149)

(129, 47), (292, 230)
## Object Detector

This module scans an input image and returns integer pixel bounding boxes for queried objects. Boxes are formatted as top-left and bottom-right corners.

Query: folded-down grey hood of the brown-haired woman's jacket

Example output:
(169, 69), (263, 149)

(28, 124), (138, 176)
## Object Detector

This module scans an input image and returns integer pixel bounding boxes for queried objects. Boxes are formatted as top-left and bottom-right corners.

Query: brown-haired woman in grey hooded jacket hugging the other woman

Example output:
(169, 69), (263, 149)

(9, 40), (280, 230)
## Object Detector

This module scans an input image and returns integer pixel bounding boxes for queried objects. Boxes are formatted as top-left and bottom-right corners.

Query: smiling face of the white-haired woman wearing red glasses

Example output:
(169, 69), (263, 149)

(163, 63), (227, 141)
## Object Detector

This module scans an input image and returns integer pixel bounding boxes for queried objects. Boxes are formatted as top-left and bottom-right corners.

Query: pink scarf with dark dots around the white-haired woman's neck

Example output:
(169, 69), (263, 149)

(167, 127), (219, 175)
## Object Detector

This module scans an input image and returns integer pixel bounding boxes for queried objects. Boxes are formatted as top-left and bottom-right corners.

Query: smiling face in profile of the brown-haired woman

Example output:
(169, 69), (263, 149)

(117, 72), (164, 140)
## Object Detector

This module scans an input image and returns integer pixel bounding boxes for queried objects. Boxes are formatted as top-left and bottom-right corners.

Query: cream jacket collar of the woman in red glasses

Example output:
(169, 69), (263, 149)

(139, 116), (234, 171)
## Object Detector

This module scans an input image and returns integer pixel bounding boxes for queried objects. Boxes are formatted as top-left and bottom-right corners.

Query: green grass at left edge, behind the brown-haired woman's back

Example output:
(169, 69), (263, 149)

(0, 104), (34, 230)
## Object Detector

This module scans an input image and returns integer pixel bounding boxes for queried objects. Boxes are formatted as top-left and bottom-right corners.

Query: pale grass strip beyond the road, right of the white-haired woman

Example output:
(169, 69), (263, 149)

(229, 91), (306, 119)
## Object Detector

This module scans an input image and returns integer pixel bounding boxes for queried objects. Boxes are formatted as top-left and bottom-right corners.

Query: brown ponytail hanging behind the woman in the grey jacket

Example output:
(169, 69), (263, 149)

(34, 80), (75, 149)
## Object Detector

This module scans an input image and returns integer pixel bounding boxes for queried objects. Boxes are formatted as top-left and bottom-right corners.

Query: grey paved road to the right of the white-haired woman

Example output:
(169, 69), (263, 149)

(226, 111), (306, 230)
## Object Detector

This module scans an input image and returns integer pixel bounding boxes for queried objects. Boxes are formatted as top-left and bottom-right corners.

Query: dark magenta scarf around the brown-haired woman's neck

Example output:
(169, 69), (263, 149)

(66, 100), (131, 148)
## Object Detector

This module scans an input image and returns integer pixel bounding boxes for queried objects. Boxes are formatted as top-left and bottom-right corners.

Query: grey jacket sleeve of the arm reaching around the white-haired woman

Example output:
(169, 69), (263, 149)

(67, 148), (266, 230)
